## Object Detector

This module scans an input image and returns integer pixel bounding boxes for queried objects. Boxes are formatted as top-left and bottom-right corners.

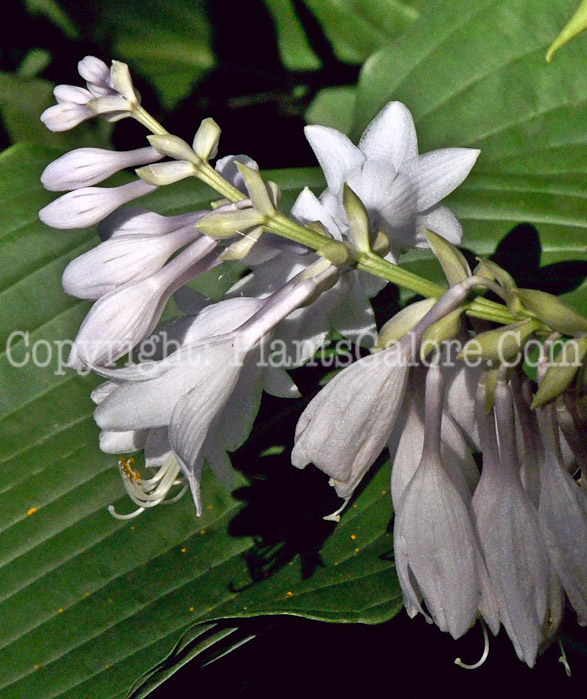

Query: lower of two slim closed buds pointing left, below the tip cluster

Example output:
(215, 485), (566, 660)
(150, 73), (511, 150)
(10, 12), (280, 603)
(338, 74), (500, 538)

(39, 180), (157, 230)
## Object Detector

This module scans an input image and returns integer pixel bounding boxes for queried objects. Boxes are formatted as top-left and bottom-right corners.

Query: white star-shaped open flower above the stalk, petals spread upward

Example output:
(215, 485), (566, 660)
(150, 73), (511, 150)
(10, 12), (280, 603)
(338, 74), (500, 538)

(305, 102), (479, 260)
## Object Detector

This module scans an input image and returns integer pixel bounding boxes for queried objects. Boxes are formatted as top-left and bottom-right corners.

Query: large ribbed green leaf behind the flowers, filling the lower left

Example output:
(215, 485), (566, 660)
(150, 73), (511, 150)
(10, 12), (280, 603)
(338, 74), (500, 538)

(0, 146), (401, 699)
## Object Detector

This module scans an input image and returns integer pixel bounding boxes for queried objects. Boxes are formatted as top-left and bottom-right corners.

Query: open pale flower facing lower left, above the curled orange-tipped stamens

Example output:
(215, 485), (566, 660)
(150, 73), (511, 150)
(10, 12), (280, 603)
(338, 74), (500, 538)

(95, 269), (331, 513)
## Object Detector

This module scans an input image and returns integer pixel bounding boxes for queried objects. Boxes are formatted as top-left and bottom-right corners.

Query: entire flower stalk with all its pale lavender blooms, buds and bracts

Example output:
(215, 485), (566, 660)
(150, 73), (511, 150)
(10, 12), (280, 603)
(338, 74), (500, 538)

(40, 56), (587, 667)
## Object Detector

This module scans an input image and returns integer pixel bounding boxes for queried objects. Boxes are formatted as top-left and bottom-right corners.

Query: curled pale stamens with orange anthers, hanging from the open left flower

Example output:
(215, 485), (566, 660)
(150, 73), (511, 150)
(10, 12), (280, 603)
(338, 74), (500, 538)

(108, 454), (188, 519)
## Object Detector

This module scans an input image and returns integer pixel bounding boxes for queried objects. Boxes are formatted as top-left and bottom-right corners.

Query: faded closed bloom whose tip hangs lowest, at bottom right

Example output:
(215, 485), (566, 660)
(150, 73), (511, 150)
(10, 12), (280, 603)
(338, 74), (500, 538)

(473, 383), (562, 667)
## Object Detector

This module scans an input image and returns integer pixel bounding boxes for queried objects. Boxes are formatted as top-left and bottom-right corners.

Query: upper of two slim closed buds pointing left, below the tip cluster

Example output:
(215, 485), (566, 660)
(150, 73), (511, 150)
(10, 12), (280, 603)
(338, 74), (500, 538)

(41, 146), (163, 192)
